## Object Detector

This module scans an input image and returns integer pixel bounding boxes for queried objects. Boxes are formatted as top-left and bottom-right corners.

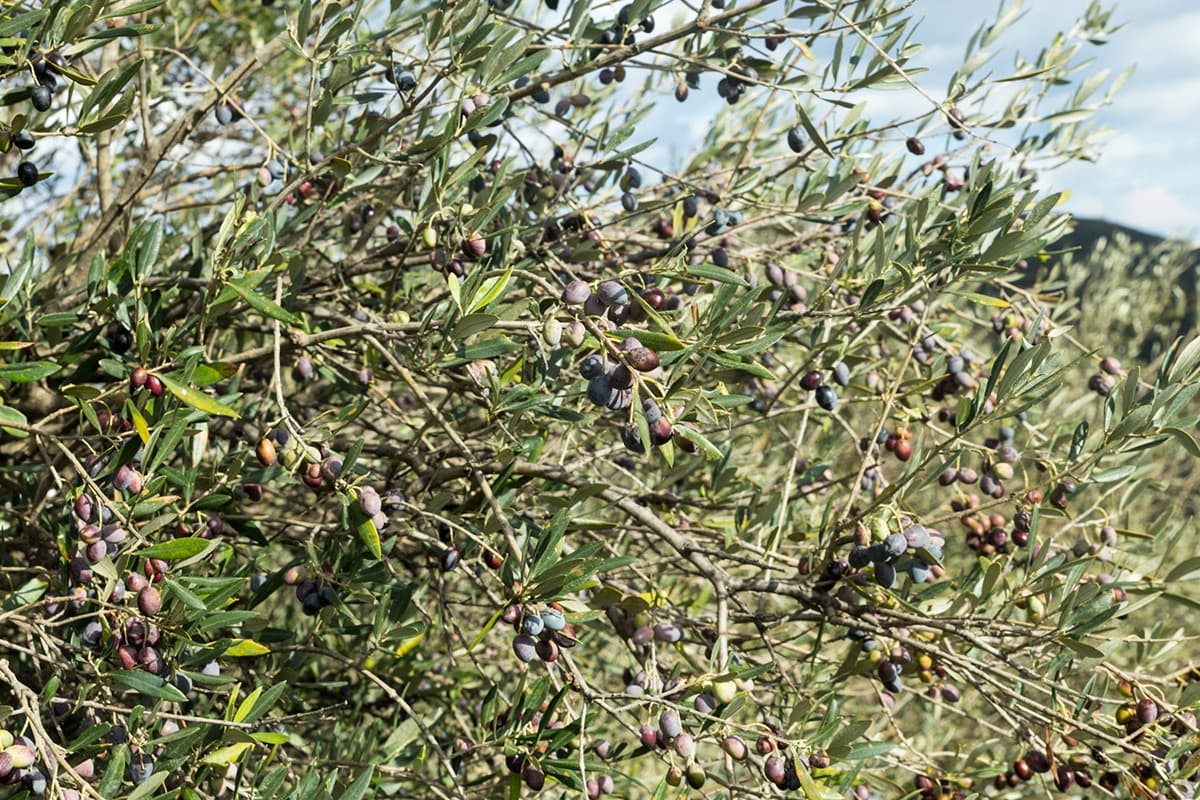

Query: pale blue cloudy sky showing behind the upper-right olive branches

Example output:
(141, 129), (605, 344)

(647, 0), (1200, 240)
